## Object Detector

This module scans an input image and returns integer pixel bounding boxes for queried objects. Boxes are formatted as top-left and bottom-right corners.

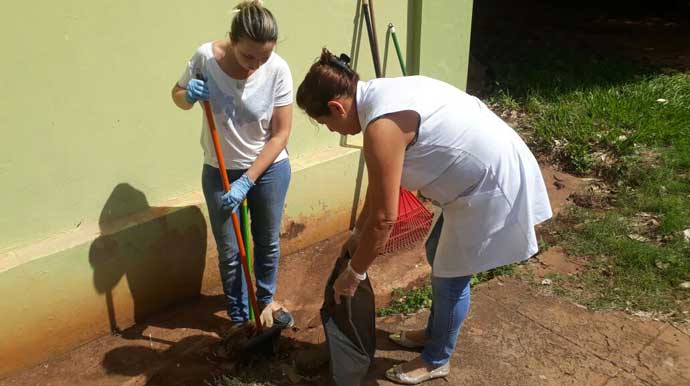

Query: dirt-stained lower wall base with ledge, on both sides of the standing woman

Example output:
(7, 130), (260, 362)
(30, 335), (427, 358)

(0, 150), (366, 377)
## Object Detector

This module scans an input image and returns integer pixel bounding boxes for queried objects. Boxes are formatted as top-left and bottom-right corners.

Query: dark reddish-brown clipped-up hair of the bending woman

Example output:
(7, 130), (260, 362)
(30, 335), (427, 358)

(297, 48), (359, 118)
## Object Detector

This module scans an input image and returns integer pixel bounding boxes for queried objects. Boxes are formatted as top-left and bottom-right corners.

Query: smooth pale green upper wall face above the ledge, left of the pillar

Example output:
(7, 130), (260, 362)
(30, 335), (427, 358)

(0, 0), (406, 251)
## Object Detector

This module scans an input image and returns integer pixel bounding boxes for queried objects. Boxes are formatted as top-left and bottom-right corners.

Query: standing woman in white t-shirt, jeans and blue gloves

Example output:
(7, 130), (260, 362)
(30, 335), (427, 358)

(172, 0), (293, 334)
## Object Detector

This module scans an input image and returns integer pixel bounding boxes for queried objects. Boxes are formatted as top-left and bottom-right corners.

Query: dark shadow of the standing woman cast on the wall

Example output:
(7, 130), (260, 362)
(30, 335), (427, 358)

(89, 183), (206, 333)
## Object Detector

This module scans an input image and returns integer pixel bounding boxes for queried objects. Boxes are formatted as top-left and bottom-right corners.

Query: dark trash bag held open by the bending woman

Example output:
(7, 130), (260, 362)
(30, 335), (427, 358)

(321, 254), (376, 386)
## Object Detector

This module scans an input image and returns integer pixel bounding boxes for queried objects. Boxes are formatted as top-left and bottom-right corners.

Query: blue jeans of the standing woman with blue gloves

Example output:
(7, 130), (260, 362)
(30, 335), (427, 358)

(201, 159), (291, 323)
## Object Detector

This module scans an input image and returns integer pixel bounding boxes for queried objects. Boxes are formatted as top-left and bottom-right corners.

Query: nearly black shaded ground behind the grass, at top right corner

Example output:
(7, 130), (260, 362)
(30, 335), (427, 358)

(468, 0), (690, 98)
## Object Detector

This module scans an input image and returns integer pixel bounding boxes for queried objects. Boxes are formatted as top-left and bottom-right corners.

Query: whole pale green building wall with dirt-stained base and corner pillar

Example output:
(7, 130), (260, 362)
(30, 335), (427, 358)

(0, 0), (471, 376)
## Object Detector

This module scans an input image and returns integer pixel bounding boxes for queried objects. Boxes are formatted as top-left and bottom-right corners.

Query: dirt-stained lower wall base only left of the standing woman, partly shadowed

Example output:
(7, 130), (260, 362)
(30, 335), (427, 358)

(0, 202), (207, 375)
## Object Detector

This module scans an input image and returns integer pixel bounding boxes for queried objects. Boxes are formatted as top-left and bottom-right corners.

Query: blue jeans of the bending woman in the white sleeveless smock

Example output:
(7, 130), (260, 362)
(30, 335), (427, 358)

(422, 217), (472, 367)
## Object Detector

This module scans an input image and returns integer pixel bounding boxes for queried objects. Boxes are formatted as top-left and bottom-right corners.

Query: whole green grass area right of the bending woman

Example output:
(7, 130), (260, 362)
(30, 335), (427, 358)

(490, 44), (690, 315)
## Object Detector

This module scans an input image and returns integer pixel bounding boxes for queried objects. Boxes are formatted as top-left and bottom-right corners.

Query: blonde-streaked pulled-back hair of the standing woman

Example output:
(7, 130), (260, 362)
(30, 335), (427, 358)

(230, 0), (278, 43)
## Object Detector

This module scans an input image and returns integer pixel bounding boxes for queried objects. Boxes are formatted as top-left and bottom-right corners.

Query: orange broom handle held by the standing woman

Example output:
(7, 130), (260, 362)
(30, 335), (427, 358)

(202, 97), (263, 332)
